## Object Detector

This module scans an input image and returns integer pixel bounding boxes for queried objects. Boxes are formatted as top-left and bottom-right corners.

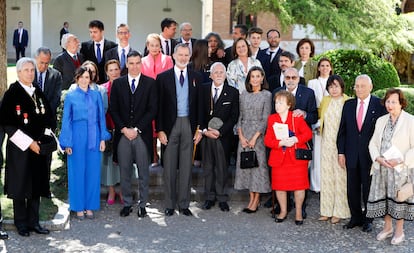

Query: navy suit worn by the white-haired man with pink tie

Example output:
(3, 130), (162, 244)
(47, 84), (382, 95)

(337, 96), (386, 225)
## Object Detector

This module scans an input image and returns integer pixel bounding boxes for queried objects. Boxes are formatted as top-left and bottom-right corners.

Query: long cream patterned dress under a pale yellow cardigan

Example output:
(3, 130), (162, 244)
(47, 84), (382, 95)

(320, 98), (351, 219)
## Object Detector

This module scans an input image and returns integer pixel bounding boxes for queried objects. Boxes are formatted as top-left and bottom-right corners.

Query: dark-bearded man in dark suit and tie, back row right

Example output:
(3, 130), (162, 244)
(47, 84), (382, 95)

(256, 29), (283, 80)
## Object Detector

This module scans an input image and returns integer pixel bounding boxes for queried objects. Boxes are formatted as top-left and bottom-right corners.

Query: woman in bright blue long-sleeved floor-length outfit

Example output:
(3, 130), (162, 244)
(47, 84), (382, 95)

(59, 67), (110, 219)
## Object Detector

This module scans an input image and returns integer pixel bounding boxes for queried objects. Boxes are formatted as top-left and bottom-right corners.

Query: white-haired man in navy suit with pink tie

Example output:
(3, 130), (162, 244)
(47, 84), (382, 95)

(337, 75), (386, 232)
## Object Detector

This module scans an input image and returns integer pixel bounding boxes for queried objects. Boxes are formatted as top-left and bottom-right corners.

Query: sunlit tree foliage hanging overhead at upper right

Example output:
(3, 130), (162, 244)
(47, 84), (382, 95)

(237, 0), (414, 54)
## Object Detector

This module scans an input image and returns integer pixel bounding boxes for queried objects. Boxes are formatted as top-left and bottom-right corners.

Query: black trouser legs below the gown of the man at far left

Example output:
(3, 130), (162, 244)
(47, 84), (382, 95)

(13, 197), (40, 230)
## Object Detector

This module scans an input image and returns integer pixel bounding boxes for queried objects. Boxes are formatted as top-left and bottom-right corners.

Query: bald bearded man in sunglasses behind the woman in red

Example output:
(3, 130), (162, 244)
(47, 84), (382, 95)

(272, 68), (318, 219)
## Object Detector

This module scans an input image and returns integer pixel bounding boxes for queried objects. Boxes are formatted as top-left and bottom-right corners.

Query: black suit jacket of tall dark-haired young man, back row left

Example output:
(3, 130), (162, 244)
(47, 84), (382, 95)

(80, 39), (118, 84)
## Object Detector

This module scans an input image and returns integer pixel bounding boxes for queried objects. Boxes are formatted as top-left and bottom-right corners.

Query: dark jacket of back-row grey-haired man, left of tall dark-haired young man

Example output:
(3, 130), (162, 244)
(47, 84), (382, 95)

(53, 51), (84, 90)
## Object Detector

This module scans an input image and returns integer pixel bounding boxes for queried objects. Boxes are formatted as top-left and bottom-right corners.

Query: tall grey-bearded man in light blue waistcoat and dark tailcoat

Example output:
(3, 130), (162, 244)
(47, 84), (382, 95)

(156, 44), (202, 216)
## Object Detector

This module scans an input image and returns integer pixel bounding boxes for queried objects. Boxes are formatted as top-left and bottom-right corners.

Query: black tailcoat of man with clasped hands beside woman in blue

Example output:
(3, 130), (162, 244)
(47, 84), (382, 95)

(109, 74), (158, 154)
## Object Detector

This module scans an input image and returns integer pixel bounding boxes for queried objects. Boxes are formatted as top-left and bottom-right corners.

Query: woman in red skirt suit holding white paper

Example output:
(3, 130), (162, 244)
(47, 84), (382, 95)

(264, 90), (312, 225)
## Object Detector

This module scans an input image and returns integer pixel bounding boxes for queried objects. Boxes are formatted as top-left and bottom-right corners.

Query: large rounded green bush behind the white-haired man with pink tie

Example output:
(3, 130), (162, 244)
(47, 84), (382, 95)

(315, 49), (400, 95)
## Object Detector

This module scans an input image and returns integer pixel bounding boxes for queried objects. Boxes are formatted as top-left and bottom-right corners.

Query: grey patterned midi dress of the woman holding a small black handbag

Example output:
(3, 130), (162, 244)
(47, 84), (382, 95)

(234, 90), (272, 193)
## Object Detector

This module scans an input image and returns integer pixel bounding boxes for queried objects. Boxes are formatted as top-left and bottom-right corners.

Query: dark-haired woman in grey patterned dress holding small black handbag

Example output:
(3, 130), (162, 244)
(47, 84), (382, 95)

(234, 66), (272, 213)
